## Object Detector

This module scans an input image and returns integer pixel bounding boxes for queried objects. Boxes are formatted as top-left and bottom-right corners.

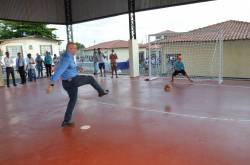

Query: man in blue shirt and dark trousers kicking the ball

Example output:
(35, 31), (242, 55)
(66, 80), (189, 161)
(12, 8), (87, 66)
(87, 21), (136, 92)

(47, 42), (109, 127)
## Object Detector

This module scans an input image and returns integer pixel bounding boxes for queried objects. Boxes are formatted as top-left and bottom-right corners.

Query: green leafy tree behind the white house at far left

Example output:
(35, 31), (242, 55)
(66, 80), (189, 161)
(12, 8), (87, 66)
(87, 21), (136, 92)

(0, 21), (57, 39)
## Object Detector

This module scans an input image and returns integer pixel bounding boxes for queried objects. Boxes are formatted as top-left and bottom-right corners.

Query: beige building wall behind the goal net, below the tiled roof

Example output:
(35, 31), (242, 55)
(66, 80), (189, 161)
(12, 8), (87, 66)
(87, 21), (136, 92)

(162, 40), (250, 78)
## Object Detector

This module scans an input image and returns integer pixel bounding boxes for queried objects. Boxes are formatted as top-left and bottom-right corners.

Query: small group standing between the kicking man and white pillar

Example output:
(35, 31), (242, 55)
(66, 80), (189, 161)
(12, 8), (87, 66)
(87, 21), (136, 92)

(93, 48), (118, 78)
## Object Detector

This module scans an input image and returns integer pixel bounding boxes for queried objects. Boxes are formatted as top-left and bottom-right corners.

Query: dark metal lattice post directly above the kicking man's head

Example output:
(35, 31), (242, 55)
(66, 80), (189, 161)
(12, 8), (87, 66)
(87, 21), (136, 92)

(64, 0), (74, 42)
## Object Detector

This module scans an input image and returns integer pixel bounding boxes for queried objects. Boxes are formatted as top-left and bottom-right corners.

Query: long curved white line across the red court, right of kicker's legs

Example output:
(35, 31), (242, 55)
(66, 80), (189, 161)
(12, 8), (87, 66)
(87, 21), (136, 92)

(83, 99), (250, 122)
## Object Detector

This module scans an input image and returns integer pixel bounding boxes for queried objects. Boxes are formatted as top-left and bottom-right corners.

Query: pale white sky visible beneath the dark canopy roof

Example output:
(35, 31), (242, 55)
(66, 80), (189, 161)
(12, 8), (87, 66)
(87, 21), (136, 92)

(49, 0), (250, 49)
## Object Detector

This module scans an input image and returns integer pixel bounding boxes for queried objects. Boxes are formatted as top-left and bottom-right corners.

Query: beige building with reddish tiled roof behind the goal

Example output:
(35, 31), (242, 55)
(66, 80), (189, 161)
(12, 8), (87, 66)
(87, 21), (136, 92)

(152, 20), (250, 79)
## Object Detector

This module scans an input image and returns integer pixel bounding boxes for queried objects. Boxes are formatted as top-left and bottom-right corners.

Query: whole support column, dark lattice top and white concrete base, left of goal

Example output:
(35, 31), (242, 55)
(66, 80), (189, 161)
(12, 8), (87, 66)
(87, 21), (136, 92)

(128, 0), (140, 77)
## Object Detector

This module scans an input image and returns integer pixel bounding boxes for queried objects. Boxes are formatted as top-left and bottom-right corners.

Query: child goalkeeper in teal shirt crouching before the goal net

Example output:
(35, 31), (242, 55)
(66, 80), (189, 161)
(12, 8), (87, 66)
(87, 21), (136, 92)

(171, 54), (193, 82)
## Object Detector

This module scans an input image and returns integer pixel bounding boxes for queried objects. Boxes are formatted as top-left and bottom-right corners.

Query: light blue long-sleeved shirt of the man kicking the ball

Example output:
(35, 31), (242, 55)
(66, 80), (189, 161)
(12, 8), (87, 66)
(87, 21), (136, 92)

(50, 52), (78, 84)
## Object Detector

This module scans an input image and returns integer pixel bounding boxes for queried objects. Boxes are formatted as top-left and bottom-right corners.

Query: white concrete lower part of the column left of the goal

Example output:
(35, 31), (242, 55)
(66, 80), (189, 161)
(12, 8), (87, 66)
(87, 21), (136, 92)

(129, 39), (140, 77)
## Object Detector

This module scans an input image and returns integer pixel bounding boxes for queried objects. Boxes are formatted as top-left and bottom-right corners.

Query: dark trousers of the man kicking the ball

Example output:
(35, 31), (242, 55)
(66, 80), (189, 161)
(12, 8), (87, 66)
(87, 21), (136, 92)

(62, 75), (104, 122)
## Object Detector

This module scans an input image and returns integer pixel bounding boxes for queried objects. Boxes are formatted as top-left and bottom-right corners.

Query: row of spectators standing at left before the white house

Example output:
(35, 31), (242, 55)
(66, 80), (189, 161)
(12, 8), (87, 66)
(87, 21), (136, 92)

(1, 52), (59, 87)
